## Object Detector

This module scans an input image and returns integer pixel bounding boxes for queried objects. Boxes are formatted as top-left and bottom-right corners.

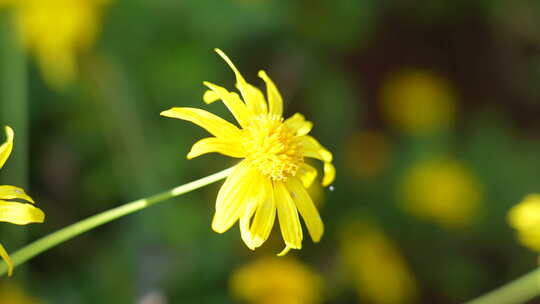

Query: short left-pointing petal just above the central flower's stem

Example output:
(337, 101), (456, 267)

(186, 137), (245, 158)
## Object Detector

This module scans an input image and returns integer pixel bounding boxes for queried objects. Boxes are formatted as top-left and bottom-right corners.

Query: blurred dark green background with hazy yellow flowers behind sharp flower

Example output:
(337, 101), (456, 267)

(0, 0), (540, 304)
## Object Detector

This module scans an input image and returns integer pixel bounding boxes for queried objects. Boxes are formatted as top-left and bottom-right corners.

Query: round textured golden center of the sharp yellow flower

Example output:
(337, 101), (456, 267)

(243, 114), (303, 181)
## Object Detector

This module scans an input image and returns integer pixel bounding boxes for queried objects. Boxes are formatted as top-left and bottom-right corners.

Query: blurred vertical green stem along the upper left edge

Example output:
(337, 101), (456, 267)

(0, 18), (28, 189)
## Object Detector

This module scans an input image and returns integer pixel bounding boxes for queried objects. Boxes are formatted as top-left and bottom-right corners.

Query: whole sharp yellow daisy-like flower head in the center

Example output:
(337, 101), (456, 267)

(161, 49), (335, 255)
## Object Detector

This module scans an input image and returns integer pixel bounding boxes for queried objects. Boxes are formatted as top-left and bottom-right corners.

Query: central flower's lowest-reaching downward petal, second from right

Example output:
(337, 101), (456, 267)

(274, 182), (302, 253)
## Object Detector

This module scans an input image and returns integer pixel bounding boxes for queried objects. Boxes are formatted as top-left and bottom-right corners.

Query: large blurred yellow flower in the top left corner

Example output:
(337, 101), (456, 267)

(0, 0), (108, 88)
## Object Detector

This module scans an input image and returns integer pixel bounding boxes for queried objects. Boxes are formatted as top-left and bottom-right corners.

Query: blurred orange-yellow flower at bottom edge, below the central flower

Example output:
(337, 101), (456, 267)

(230, 257), (322, 304)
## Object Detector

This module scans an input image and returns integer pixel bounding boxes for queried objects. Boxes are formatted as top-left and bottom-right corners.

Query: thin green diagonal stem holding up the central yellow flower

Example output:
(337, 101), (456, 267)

(0, 168), (233, 276)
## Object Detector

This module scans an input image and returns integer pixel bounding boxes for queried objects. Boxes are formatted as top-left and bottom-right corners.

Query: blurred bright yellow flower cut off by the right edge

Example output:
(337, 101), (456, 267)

(508, 194), (540, 252)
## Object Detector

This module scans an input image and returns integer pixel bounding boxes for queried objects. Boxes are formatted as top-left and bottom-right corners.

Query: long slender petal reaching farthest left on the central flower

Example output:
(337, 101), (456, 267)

(160, 108), (240, 140)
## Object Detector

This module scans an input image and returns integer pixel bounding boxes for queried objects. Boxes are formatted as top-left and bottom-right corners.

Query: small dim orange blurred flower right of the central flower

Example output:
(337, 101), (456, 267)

(345, 131), (390, 179)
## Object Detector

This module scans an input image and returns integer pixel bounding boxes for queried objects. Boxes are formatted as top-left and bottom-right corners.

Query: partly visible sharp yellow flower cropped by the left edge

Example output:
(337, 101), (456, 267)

(0, 127), (45, 276)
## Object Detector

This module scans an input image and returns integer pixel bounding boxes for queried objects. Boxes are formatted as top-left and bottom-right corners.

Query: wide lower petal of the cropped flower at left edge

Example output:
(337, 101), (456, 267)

(0, 200), (45, 225)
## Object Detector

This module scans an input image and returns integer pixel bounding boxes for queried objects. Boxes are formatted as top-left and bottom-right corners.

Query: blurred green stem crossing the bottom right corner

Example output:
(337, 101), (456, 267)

(465, 268), (540, 304)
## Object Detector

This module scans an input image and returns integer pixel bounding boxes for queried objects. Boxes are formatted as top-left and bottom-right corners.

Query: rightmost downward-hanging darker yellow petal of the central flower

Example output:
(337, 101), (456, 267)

(286, 177), (324, 242)
